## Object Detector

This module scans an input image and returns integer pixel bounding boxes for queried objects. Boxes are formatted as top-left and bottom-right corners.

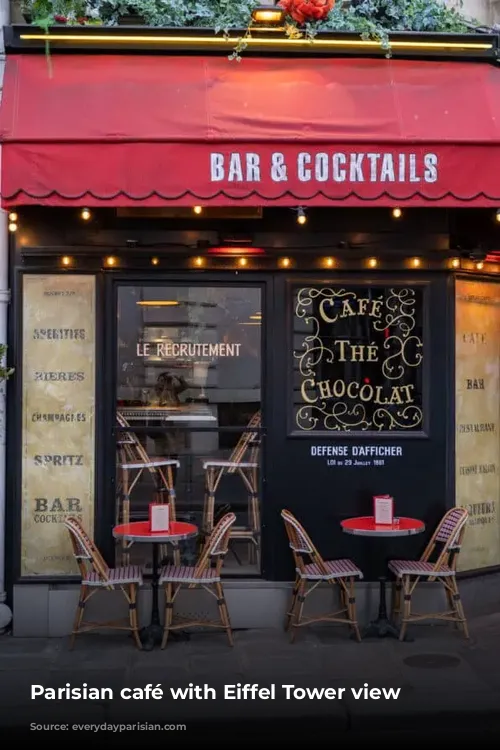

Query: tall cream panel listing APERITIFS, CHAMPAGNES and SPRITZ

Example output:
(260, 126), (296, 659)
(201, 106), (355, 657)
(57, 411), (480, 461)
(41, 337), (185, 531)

(21, 274), (95, 576)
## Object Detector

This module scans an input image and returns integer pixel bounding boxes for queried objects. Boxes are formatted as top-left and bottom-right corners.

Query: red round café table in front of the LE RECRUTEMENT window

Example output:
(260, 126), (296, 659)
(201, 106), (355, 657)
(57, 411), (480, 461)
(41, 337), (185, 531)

(113, 521), (198, 651)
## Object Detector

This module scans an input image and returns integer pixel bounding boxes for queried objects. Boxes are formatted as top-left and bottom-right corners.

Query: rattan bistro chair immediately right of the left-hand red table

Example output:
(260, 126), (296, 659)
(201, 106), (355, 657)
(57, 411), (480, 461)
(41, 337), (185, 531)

(160, 513), (236, 648)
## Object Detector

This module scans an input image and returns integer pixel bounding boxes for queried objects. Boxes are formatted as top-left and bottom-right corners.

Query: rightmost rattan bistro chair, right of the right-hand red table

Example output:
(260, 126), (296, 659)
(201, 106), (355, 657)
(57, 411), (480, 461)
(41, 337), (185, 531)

(389, 508), (469, 641)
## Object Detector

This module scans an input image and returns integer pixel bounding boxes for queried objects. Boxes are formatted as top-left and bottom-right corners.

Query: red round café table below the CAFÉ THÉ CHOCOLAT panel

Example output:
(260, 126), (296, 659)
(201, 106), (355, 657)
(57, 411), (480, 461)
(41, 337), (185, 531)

(340, 516), (425, 640)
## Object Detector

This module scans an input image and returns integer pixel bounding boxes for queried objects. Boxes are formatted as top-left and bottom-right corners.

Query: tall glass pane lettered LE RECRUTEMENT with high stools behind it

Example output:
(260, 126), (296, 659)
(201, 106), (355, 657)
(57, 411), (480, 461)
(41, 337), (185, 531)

(116, 285), (262, 575)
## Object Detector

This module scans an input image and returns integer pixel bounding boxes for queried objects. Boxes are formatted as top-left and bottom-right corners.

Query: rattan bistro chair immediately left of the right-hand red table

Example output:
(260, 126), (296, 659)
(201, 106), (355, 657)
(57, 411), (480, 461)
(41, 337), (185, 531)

(281, 510), (363, 642)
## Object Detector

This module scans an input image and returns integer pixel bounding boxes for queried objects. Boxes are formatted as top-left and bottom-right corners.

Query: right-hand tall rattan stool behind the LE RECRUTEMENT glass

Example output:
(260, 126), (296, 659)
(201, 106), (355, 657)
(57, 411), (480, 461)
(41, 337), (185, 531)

(202, 410), (261, 565)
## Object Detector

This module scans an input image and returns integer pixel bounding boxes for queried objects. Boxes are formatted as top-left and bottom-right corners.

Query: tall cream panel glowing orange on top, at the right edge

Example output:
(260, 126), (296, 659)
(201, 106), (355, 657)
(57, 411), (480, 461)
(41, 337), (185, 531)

(455, 279), (500, 570)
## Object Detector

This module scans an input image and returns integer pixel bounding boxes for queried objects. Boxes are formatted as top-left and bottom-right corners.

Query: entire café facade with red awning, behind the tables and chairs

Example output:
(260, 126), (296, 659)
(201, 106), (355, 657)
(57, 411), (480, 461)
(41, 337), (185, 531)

(0, 26), (500, 636)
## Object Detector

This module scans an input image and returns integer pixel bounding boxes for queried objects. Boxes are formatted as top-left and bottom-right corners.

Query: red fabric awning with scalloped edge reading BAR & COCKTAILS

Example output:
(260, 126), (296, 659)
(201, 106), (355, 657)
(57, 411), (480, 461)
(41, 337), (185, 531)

(0, 54), (500, 207)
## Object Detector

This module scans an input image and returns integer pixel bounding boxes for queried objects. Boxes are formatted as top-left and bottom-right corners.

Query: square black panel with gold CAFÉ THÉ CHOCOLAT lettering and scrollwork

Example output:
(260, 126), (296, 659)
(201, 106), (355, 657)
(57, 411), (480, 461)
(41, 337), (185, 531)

(293, 286), (424, 434)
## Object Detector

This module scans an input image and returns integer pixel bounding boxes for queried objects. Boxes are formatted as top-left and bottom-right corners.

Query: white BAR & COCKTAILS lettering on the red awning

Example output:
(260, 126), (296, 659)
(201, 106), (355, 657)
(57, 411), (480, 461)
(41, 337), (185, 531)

(210, 150), (439, 185)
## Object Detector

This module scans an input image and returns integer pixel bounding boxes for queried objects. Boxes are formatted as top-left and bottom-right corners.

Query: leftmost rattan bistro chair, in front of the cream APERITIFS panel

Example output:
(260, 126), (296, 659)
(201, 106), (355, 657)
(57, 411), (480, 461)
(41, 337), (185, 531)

(64, 517), (142, 649)
